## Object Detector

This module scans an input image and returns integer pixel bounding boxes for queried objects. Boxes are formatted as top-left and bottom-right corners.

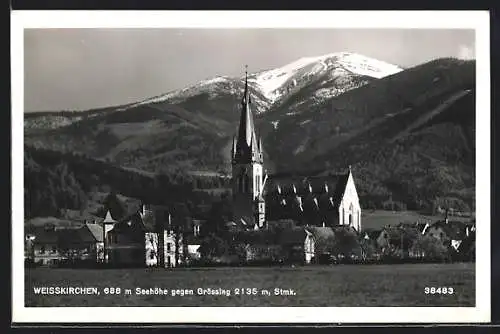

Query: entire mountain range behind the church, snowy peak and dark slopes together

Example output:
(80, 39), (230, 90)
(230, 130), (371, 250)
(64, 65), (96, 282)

(25, 53), (475, 213)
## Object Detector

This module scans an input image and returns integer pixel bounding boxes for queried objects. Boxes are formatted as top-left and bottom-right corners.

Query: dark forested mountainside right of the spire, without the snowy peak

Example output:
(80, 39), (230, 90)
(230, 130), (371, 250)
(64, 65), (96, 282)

(261, 59), (475, 210)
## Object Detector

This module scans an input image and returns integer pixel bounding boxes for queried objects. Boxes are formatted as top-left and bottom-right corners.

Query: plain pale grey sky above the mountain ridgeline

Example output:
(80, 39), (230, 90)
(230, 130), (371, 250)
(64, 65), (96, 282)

(24, 28), (475, 112)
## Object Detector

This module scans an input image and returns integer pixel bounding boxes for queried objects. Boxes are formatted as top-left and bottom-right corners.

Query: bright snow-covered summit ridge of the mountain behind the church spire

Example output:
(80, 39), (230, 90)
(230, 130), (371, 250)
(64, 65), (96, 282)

(117, 52), (402, 113)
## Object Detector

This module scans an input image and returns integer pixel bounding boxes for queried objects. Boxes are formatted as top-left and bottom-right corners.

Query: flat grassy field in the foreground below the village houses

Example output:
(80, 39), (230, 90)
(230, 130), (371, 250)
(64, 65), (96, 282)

(25, 263), (475, 306)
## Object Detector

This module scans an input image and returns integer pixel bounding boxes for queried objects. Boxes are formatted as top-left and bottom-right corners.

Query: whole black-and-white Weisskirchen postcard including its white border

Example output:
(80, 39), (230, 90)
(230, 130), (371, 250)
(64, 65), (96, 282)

(11, 11), (491, 323)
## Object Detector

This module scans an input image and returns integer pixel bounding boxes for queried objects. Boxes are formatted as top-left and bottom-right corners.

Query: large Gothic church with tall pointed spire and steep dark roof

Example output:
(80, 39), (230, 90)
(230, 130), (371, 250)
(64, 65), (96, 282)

(231, 68), (361, 232)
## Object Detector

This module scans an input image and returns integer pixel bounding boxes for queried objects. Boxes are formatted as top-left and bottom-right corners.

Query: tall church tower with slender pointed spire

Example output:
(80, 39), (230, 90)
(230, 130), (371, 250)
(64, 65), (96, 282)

(231, 65), (265, 228)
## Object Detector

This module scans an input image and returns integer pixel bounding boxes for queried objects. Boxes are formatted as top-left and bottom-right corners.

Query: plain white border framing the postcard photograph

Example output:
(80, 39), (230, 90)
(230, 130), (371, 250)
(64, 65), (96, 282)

(11, 11), (491, 323)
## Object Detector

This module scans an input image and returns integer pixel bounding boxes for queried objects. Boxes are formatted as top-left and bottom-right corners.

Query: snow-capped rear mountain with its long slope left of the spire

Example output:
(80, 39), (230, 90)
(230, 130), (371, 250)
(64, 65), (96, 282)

(25, 53), (401, 175)
